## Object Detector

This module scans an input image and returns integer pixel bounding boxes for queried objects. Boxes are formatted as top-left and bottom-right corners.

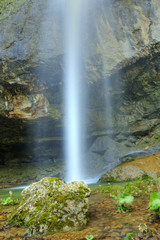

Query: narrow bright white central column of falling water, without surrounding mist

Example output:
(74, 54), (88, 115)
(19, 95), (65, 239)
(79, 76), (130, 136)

(64, 0), (84, 182)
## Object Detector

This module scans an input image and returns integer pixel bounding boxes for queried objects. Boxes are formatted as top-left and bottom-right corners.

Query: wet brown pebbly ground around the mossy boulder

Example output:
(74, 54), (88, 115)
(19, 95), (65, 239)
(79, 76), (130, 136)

(0, 181), (160, 240)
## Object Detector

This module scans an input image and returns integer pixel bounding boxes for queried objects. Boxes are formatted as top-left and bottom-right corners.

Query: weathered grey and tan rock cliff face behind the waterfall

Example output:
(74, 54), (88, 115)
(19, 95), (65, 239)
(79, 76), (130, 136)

(0, 0), (160, 185)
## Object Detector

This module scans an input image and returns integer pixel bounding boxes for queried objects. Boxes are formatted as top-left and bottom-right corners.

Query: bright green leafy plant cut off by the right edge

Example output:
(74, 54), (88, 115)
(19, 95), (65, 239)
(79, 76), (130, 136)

(148, 192), (160, 216)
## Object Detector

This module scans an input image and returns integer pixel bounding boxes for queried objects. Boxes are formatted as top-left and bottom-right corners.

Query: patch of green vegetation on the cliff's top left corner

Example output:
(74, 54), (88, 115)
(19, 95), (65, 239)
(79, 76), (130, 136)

(0, 0), (26, 20)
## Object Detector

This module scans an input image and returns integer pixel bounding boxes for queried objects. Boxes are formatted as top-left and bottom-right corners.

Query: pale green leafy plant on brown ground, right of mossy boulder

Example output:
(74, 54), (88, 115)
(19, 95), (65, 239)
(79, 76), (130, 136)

(112, 192), (134, 213)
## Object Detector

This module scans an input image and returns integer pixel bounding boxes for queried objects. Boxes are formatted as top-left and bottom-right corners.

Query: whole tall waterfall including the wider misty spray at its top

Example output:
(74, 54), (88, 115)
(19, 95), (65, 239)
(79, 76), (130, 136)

(42, 0), (100, 182)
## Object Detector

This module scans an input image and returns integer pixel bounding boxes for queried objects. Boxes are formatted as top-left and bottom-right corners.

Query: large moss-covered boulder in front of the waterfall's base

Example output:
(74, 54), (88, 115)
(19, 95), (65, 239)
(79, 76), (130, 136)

(8, 178), (90, 236)
